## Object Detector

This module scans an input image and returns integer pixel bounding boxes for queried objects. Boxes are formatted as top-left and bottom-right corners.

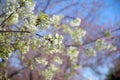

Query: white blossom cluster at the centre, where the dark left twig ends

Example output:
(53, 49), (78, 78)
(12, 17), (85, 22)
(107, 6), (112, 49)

(44, 34), (63, 54)
